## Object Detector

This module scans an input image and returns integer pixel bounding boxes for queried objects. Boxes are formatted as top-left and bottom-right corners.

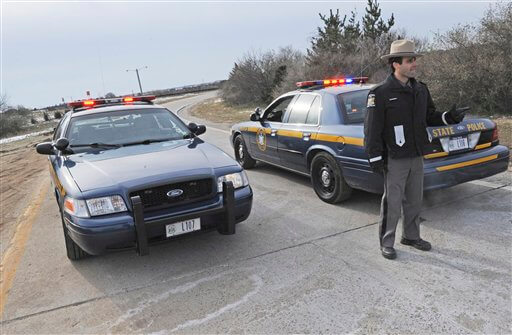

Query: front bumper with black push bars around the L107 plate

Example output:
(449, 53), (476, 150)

(65, 182), (253, 255)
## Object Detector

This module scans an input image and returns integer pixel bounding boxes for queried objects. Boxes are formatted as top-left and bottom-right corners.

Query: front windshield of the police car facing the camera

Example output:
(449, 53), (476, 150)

(66, 108), (191, 151)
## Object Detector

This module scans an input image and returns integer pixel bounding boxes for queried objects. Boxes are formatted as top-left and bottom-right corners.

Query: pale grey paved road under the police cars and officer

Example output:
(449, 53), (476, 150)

(1, 93), (512, 334)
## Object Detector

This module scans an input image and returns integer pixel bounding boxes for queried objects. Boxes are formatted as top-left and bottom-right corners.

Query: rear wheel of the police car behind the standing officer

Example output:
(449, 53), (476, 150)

(311, 152), (352, 204)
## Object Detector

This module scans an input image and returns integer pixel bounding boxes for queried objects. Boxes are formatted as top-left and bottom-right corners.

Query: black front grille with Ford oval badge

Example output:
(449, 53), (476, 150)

(130, 178), (213, 210)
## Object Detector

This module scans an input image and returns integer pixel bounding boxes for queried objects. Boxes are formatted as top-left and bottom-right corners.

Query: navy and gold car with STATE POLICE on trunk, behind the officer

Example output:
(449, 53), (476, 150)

(231, 77), (509, 203)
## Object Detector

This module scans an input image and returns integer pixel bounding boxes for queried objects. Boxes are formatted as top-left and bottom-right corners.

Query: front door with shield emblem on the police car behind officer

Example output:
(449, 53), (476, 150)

(250, 95), (295, 164)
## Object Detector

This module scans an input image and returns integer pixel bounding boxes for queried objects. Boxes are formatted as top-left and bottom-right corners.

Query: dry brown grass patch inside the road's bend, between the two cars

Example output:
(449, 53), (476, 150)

(190, 98), (256, 124)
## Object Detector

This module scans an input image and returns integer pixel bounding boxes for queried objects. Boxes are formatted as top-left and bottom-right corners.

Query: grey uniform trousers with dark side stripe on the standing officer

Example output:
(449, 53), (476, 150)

(379, 156), (423, 247)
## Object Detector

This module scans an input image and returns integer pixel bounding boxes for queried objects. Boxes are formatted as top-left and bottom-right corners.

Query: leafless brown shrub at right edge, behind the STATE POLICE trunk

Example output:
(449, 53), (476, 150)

(420, 3), (512, 115)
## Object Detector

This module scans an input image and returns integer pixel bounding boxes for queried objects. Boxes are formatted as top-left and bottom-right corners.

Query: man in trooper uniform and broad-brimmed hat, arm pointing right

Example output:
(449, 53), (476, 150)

(364, 40), (464, 259)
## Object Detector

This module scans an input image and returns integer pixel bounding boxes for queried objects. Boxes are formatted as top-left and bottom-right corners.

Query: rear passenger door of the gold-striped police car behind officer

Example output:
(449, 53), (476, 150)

(277, 93), (322, 173)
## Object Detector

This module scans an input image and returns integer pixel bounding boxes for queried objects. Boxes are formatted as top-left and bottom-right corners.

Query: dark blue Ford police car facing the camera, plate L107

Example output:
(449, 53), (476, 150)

(36, 96), (252, 260)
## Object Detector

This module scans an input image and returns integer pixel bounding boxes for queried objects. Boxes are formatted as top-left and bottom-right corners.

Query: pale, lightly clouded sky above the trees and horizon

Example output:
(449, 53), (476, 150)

(1, 0), (496, 107)
